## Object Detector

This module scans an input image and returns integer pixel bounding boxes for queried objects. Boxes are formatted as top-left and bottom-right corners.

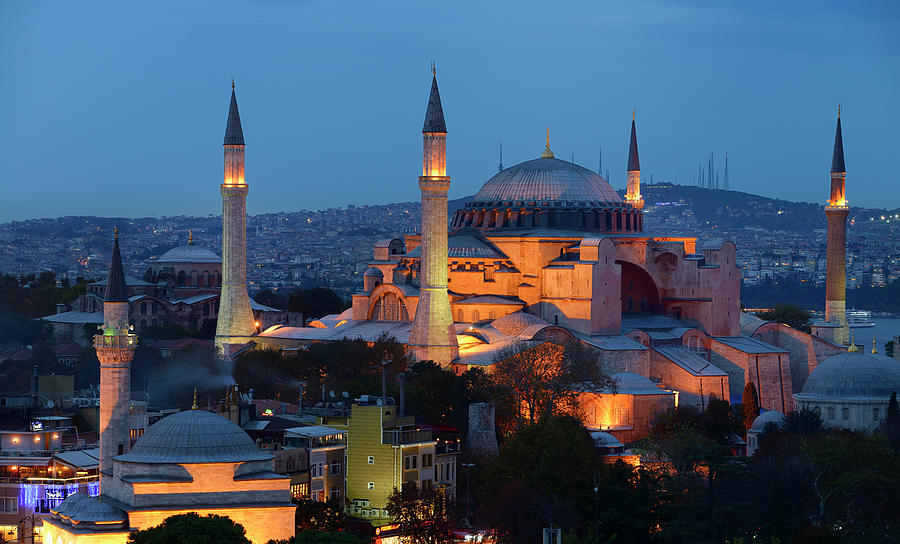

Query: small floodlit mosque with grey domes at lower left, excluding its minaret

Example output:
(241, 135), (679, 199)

(44, 408), (295, 544)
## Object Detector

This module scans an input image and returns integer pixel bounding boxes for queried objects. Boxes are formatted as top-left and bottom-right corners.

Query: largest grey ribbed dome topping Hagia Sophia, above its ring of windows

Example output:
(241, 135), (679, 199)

(472, 158), (622, 202)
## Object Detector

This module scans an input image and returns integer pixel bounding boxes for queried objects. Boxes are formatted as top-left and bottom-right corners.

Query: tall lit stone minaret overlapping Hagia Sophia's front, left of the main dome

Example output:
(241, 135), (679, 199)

(409, 64), (459, 366)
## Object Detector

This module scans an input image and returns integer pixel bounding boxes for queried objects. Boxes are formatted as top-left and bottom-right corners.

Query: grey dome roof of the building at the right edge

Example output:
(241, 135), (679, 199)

(798, 351), (900, 400)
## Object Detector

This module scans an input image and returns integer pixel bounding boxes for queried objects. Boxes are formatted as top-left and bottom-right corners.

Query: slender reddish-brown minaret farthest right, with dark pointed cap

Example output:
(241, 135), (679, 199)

(825, 106), (850, 344)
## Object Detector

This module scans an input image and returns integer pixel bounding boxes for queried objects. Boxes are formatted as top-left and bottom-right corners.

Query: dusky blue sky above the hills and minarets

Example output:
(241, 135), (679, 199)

(0, 0), (900, 221)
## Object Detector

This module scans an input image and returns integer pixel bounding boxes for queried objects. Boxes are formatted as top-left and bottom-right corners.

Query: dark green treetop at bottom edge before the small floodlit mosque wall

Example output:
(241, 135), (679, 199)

(128, 512), (251, 544)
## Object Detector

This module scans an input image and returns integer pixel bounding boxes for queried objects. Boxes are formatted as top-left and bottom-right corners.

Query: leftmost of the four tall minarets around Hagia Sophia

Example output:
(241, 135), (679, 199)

(216, 81), (256, 356)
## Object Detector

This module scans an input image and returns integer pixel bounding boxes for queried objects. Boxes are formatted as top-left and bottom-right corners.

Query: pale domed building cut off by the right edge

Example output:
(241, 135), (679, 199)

(794, 348), (900, 431)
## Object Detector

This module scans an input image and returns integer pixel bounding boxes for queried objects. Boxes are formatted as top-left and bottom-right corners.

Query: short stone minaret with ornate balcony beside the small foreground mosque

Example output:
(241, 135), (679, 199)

(94, 230), (137, 486)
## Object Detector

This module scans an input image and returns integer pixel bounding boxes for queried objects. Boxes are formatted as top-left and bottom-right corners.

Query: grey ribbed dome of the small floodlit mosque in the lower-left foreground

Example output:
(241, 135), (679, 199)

(115, 410), (272, 464)
